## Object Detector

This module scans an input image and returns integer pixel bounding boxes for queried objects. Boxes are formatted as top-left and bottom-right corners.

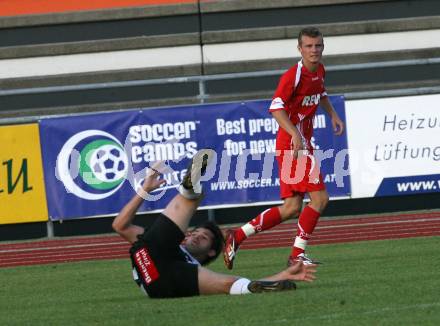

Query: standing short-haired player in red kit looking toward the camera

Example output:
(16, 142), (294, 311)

(224, 27), (344, 269)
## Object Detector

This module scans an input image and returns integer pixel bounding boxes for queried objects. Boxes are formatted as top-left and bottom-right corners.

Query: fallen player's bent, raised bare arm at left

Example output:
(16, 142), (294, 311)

(112, 166), (165, 243)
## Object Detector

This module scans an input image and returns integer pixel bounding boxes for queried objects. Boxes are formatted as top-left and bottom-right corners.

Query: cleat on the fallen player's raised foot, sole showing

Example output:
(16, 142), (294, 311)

(181, 148), (215, 193)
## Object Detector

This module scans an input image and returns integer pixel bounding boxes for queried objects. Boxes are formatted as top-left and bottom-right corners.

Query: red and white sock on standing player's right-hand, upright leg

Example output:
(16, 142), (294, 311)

(291, 205), (321, 257)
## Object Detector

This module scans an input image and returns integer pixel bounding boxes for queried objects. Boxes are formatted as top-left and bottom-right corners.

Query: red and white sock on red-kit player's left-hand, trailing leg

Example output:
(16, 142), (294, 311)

(234, 207), (281, 244)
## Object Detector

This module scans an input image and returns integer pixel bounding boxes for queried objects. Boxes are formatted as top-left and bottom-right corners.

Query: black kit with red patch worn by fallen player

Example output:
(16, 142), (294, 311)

(130, 215), (199, 298)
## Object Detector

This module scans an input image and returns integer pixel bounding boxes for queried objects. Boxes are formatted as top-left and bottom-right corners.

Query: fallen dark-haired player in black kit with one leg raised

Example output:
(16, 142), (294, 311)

(112, 149), (316, 298)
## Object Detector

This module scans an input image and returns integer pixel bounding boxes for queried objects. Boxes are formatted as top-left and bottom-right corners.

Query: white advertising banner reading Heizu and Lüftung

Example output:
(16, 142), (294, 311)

(346, 94), (440, 198)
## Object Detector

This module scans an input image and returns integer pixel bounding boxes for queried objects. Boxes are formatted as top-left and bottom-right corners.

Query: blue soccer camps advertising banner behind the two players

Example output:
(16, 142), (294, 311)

(40, 97), (350, 220)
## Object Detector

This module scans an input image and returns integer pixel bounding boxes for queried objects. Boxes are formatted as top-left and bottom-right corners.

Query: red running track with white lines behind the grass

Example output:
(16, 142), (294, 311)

(0, 212), (440, 268)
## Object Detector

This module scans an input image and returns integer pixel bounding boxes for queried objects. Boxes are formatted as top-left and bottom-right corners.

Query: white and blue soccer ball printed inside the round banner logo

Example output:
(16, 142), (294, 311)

(89, 144), (128, 183)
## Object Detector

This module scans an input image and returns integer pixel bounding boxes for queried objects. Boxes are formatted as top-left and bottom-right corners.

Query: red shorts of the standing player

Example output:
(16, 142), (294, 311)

(276, 150), (325, 199)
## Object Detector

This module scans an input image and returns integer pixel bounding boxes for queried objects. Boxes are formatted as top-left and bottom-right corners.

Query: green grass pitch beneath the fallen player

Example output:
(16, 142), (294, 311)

(0, 237), (440, 326)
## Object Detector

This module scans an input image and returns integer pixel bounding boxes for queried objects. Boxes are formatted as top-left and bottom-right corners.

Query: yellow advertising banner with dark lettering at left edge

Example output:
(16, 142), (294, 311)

(0, 124), (48, 224)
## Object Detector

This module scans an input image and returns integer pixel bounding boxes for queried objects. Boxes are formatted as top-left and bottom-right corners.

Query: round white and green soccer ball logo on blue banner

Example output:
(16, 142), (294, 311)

(56, 130), (129, 200)
